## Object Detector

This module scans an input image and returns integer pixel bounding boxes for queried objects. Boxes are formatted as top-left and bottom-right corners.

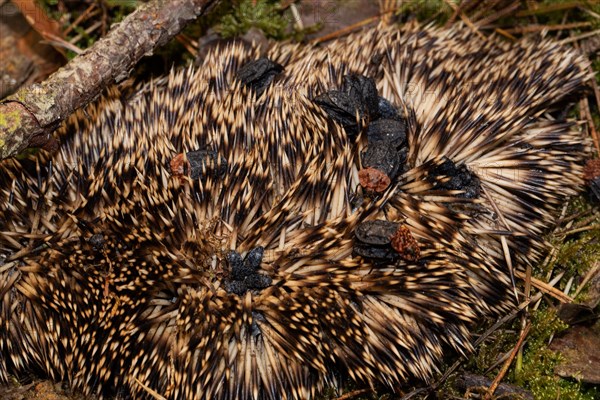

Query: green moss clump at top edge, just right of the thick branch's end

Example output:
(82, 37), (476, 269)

(219, 0), (289, 39)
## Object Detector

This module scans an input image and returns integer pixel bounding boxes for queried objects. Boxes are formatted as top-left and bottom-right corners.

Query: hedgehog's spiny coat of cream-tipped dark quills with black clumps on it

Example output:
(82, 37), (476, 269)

(0, 22), (590, 399)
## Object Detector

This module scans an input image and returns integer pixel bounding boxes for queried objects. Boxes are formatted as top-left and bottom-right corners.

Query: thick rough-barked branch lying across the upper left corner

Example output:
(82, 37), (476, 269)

(0, 0), (217, 159)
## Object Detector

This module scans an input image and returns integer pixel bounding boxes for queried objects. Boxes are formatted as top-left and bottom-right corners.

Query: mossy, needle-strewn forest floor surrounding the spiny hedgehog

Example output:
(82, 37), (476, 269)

(0, 0), (600, 400)
